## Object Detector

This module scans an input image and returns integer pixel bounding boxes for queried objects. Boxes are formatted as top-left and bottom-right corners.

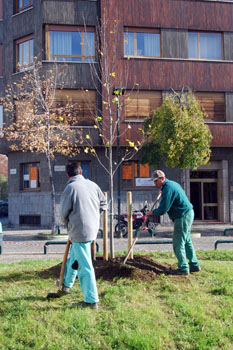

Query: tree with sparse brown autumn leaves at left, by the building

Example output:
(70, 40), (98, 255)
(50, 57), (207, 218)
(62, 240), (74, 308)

(4, 60), (82, 234)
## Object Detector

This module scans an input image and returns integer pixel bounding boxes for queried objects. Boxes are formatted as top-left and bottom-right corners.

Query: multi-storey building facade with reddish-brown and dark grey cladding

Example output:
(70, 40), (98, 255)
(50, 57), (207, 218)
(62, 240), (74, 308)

(0, 0), (233, 227)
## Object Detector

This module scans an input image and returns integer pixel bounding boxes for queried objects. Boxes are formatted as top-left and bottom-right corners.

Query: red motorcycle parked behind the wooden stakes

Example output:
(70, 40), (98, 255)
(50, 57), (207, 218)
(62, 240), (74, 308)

(114, 202), (156, 237)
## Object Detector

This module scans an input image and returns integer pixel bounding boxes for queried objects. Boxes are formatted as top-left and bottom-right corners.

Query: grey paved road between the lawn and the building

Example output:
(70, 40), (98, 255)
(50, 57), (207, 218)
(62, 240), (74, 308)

(0, 224), (233, 262)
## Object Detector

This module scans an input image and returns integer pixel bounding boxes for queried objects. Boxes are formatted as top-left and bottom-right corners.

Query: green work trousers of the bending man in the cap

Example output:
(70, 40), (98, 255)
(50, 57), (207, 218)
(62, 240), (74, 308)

(173, 210), (200, 271)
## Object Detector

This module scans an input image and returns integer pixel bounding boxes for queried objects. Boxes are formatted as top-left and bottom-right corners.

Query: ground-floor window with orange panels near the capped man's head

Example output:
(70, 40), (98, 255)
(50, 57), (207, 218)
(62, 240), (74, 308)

(121, 160), (154, 189)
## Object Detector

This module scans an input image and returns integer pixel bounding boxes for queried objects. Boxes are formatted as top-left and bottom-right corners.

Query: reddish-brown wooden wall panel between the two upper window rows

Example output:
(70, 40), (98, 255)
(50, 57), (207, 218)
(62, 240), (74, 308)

(122, 59), (233, 91)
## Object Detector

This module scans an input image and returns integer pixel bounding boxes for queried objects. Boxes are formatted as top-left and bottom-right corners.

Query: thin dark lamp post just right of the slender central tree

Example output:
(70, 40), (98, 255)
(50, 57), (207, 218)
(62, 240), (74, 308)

(113, 86), (125, 236)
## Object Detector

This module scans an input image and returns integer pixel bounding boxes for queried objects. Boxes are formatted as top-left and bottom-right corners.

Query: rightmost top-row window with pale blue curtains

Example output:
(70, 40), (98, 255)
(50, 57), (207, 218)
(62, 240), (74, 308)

(188, 32), (223, 60)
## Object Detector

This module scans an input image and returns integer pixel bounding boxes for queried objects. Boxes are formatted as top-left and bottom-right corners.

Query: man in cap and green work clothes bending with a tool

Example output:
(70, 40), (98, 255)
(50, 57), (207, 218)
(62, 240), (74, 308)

(147, 170), (201, 275)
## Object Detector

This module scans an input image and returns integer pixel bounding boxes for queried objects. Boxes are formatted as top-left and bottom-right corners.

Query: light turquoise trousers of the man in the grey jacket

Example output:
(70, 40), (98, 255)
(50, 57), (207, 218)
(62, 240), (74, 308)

(63, 241), (99, 303)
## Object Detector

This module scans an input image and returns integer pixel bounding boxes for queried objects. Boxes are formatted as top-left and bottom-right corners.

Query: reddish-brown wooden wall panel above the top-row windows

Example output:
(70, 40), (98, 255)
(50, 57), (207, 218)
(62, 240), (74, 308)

(101, 0), (233, 31)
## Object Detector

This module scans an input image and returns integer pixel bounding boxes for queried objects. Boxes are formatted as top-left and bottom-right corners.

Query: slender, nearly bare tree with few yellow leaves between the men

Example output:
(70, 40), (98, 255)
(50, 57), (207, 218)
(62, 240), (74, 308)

(84, 15), (144, 258)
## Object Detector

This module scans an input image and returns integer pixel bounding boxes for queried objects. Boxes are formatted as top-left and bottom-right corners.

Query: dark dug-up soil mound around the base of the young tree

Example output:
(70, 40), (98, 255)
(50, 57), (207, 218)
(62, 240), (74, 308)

(40, 255), (178, 282)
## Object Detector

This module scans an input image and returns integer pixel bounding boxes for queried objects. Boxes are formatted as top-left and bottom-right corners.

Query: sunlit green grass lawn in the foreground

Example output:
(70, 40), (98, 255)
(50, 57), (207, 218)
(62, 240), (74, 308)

(0, 250), (233, 350)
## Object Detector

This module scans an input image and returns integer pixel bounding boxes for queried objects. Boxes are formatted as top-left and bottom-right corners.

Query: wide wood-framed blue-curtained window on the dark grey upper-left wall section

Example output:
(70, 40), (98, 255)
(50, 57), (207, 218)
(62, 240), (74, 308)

(46, 26), (95, 62)
